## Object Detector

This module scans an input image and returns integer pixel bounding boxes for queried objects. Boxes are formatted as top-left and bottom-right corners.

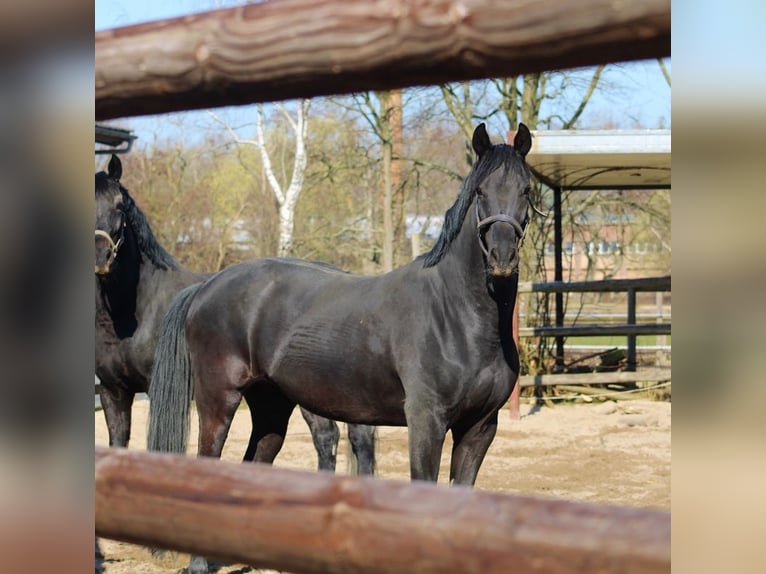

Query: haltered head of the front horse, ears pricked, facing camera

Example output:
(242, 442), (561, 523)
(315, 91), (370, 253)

(473, 124), (532, 277)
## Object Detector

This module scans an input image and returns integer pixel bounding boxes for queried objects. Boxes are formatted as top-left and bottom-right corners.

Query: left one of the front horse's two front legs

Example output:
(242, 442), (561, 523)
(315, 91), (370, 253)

(404, 399), (447, 482)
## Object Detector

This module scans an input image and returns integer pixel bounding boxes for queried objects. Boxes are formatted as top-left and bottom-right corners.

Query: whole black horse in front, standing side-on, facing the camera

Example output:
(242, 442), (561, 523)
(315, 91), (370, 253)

(149, 124), (532, 572)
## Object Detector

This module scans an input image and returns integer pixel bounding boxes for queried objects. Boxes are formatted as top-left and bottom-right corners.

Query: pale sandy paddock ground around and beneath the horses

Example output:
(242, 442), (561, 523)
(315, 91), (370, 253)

(95, 400), (671, 574)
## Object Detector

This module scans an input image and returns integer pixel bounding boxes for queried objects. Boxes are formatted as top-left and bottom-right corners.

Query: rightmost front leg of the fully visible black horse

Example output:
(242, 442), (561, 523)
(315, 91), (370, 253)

(450, 411), (497, 486)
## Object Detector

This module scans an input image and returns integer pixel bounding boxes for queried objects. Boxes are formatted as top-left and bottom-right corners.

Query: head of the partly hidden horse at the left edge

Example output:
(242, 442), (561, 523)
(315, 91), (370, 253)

(96, 155), (127, 275)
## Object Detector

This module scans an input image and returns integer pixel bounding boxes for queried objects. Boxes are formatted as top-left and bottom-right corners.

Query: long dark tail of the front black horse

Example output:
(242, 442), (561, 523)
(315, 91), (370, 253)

(146, 283), (202, 454)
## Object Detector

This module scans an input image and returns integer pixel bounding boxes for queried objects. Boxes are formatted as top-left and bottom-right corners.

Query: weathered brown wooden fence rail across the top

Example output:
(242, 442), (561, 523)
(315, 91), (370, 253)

(96, 0), (670, 120)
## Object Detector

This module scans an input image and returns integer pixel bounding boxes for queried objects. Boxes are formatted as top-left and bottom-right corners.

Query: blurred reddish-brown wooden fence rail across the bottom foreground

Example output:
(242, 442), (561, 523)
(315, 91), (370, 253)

(96, 448), (670, 574)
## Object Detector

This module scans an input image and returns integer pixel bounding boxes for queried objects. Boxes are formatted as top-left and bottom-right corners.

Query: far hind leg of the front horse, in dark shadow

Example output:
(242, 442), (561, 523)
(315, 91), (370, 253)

(243, 383), (295, 464)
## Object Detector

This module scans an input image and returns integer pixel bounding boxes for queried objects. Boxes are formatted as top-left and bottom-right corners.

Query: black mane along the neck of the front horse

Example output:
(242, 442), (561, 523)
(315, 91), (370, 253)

(426, 144), (516, 267)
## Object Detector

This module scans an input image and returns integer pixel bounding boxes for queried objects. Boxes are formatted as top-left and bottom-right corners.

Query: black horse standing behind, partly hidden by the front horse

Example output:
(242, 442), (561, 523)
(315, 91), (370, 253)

(95, 155), (375, 474)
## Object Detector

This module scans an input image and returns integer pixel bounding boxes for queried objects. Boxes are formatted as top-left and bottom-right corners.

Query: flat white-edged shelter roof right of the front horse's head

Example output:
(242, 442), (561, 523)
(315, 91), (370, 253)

(527, 130), (670, 189)
